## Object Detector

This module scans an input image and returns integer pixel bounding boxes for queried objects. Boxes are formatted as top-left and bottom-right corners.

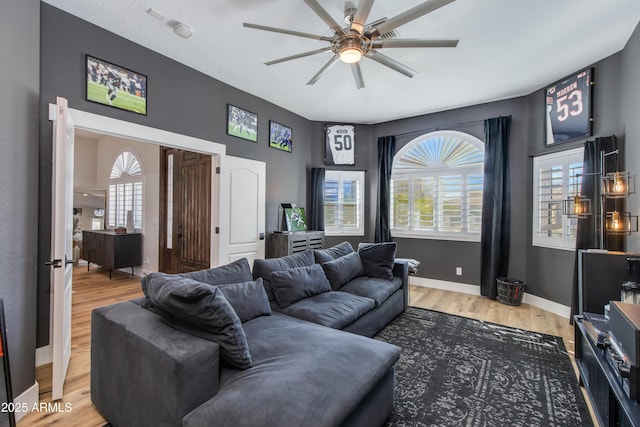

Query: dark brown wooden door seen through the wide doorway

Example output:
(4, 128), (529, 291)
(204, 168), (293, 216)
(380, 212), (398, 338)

(159, 148), (211, 273)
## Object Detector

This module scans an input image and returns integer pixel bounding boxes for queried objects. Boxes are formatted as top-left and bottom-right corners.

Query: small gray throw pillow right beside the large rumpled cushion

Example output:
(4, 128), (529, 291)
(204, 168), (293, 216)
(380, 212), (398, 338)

(218, 277), (271, 323)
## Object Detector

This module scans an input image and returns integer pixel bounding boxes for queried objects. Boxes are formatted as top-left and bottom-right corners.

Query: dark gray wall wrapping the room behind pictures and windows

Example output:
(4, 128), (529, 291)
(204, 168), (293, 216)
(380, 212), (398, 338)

(38, 4), (640, 345)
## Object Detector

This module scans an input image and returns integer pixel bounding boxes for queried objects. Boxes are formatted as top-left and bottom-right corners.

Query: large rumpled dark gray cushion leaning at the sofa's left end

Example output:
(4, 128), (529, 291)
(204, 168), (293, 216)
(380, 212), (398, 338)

(146, 273), (252, 369)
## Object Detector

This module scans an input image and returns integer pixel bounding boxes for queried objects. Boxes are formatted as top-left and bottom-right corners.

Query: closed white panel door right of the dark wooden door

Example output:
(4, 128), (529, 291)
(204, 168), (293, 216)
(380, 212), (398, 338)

(218, 155), (267, 265)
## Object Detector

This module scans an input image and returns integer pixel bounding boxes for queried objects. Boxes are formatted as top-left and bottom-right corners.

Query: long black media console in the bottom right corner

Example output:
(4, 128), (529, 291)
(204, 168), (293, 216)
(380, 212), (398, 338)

(574, 316), (640, 427)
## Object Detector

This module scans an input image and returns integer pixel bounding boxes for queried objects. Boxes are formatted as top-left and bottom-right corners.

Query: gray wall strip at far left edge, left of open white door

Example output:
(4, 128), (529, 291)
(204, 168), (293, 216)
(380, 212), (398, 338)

(0, 0), (40, 397)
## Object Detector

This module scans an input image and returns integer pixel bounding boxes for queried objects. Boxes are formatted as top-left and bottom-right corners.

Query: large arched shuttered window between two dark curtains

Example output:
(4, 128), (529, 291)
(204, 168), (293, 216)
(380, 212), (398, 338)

(391, 131), (484, 241)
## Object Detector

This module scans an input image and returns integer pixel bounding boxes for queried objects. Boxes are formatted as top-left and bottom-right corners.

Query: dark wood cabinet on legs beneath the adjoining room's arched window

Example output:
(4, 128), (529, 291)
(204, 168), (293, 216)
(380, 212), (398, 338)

(82, 230), (142, 278)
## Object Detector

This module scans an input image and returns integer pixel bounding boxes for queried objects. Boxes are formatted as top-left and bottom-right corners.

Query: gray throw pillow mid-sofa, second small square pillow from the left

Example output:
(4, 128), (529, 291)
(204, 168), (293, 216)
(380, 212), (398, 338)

(270, 264), (331, 308)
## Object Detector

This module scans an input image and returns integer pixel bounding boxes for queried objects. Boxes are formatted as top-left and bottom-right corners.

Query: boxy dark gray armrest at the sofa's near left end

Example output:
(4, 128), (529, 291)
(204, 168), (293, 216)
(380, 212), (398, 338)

(91, 301), (220, 426)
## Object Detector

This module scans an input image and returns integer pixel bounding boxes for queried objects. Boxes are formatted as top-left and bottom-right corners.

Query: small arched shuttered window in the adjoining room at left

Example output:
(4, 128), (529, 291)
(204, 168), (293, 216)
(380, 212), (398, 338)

(107, 151), (143, 231)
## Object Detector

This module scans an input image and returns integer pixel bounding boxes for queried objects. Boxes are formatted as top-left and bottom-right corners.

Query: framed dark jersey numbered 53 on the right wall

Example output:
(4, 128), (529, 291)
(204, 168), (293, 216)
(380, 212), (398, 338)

(545, 68), (593, 146)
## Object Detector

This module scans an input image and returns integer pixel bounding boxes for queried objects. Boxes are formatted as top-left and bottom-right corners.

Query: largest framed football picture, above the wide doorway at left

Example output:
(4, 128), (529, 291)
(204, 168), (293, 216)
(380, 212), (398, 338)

(86, 55), (147, 116)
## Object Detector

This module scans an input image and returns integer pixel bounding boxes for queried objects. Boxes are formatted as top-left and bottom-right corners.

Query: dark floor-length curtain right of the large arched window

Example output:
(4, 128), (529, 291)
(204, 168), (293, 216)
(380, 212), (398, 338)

(480, 116), (511, 299)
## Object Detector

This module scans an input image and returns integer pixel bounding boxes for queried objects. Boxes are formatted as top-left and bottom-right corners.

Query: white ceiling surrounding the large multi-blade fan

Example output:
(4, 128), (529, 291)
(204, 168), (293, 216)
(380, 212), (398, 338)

(44, 0), (640, 124)
